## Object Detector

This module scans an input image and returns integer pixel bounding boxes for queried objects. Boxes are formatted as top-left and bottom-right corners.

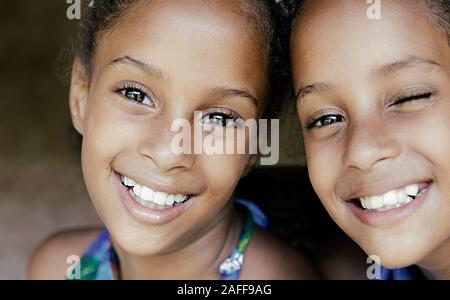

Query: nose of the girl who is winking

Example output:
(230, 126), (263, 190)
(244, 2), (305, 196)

(345, 120), (401, 172)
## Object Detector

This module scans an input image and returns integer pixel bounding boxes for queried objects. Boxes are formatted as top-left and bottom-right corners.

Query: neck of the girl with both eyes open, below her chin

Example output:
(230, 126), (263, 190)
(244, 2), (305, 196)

(114, 204), (241, 280)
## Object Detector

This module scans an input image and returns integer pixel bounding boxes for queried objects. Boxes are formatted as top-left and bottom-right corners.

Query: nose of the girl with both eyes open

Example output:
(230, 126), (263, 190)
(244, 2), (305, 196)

(139, 118), (195, 173)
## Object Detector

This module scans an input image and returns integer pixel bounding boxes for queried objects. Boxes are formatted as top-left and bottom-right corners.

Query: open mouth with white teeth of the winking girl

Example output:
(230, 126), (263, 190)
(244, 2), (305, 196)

(350, 182), (432, 212)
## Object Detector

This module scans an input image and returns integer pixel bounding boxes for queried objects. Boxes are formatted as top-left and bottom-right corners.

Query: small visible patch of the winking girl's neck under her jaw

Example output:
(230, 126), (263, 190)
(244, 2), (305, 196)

(418, 239), (450, 280)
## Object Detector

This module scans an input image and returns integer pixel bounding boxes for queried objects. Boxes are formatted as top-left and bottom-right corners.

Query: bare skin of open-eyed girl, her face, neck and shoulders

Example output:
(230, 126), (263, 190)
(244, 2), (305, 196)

(30, 0), (315, 279)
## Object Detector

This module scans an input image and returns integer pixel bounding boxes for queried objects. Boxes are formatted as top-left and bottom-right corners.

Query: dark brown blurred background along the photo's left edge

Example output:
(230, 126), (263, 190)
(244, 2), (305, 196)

(0, 0), (102, 279)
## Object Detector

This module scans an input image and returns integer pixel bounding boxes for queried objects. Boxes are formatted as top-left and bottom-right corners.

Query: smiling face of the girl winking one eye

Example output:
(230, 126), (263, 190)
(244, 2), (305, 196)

(292, 0), (450, 267)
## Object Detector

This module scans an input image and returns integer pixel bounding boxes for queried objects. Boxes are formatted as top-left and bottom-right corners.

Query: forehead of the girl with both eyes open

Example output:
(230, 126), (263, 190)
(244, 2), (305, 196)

(91, 0), (267, 97)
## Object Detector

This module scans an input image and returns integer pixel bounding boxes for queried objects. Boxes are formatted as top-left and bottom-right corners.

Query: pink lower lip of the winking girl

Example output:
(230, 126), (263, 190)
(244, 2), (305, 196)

(347, 183), (433, 227)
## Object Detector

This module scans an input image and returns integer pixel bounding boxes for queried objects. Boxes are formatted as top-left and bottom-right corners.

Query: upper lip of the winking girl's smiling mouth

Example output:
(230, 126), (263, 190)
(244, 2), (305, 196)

(342, 179), (432, 201)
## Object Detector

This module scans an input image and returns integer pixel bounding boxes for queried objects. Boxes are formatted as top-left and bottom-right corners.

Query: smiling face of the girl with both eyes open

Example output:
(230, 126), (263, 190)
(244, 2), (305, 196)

(71, 0), (267, 255)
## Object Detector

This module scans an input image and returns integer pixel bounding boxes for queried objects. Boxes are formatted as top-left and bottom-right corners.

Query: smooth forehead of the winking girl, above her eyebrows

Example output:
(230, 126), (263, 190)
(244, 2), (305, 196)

(292, 0), (450, 81)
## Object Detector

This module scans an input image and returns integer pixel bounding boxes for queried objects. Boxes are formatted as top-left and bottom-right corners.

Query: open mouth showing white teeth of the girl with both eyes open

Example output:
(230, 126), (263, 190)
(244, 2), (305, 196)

(120, 175), (191, 209)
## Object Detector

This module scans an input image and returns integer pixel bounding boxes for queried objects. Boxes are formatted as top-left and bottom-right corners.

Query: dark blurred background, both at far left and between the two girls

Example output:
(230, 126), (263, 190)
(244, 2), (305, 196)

(0, 0), (335, 279)
